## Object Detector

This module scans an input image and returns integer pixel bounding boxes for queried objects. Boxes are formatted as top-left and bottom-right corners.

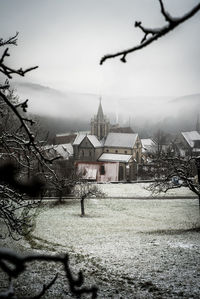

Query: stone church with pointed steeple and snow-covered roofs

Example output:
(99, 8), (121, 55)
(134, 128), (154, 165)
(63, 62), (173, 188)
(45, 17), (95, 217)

(73, 100), (142, 182)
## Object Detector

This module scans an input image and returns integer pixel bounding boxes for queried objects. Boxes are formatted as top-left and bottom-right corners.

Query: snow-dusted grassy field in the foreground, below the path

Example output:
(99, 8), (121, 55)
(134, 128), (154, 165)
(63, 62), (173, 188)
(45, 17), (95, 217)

(0, 198), (200, 299)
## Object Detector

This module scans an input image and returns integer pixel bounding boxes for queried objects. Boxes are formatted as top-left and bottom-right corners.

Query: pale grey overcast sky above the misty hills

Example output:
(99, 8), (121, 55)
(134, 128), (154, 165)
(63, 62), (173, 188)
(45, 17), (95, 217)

(0, 0), (200, 96)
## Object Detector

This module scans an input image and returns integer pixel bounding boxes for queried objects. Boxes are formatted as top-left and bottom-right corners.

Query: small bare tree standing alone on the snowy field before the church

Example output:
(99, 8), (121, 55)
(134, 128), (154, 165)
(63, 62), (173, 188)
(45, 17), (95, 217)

(73, 181), (105, 217)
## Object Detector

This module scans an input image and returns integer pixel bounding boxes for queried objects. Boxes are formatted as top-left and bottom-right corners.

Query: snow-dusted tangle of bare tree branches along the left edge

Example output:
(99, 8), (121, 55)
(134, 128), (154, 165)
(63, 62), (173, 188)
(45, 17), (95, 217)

(0, 33), (61, 238)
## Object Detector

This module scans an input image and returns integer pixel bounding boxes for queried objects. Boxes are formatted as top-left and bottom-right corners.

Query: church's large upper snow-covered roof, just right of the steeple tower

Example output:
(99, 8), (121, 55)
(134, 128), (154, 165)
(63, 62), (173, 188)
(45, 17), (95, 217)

(104, 133), (138, 148)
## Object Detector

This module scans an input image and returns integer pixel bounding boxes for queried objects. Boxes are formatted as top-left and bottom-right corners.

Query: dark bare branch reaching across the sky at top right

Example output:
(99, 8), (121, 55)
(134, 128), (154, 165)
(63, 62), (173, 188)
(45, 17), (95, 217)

(100, 0), (200, 64)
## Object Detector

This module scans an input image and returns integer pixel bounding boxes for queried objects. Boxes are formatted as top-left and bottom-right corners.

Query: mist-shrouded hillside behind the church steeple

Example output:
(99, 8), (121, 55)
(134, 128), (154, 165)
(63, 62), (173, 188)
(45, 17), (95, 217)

(14, 82), (200, 137)
